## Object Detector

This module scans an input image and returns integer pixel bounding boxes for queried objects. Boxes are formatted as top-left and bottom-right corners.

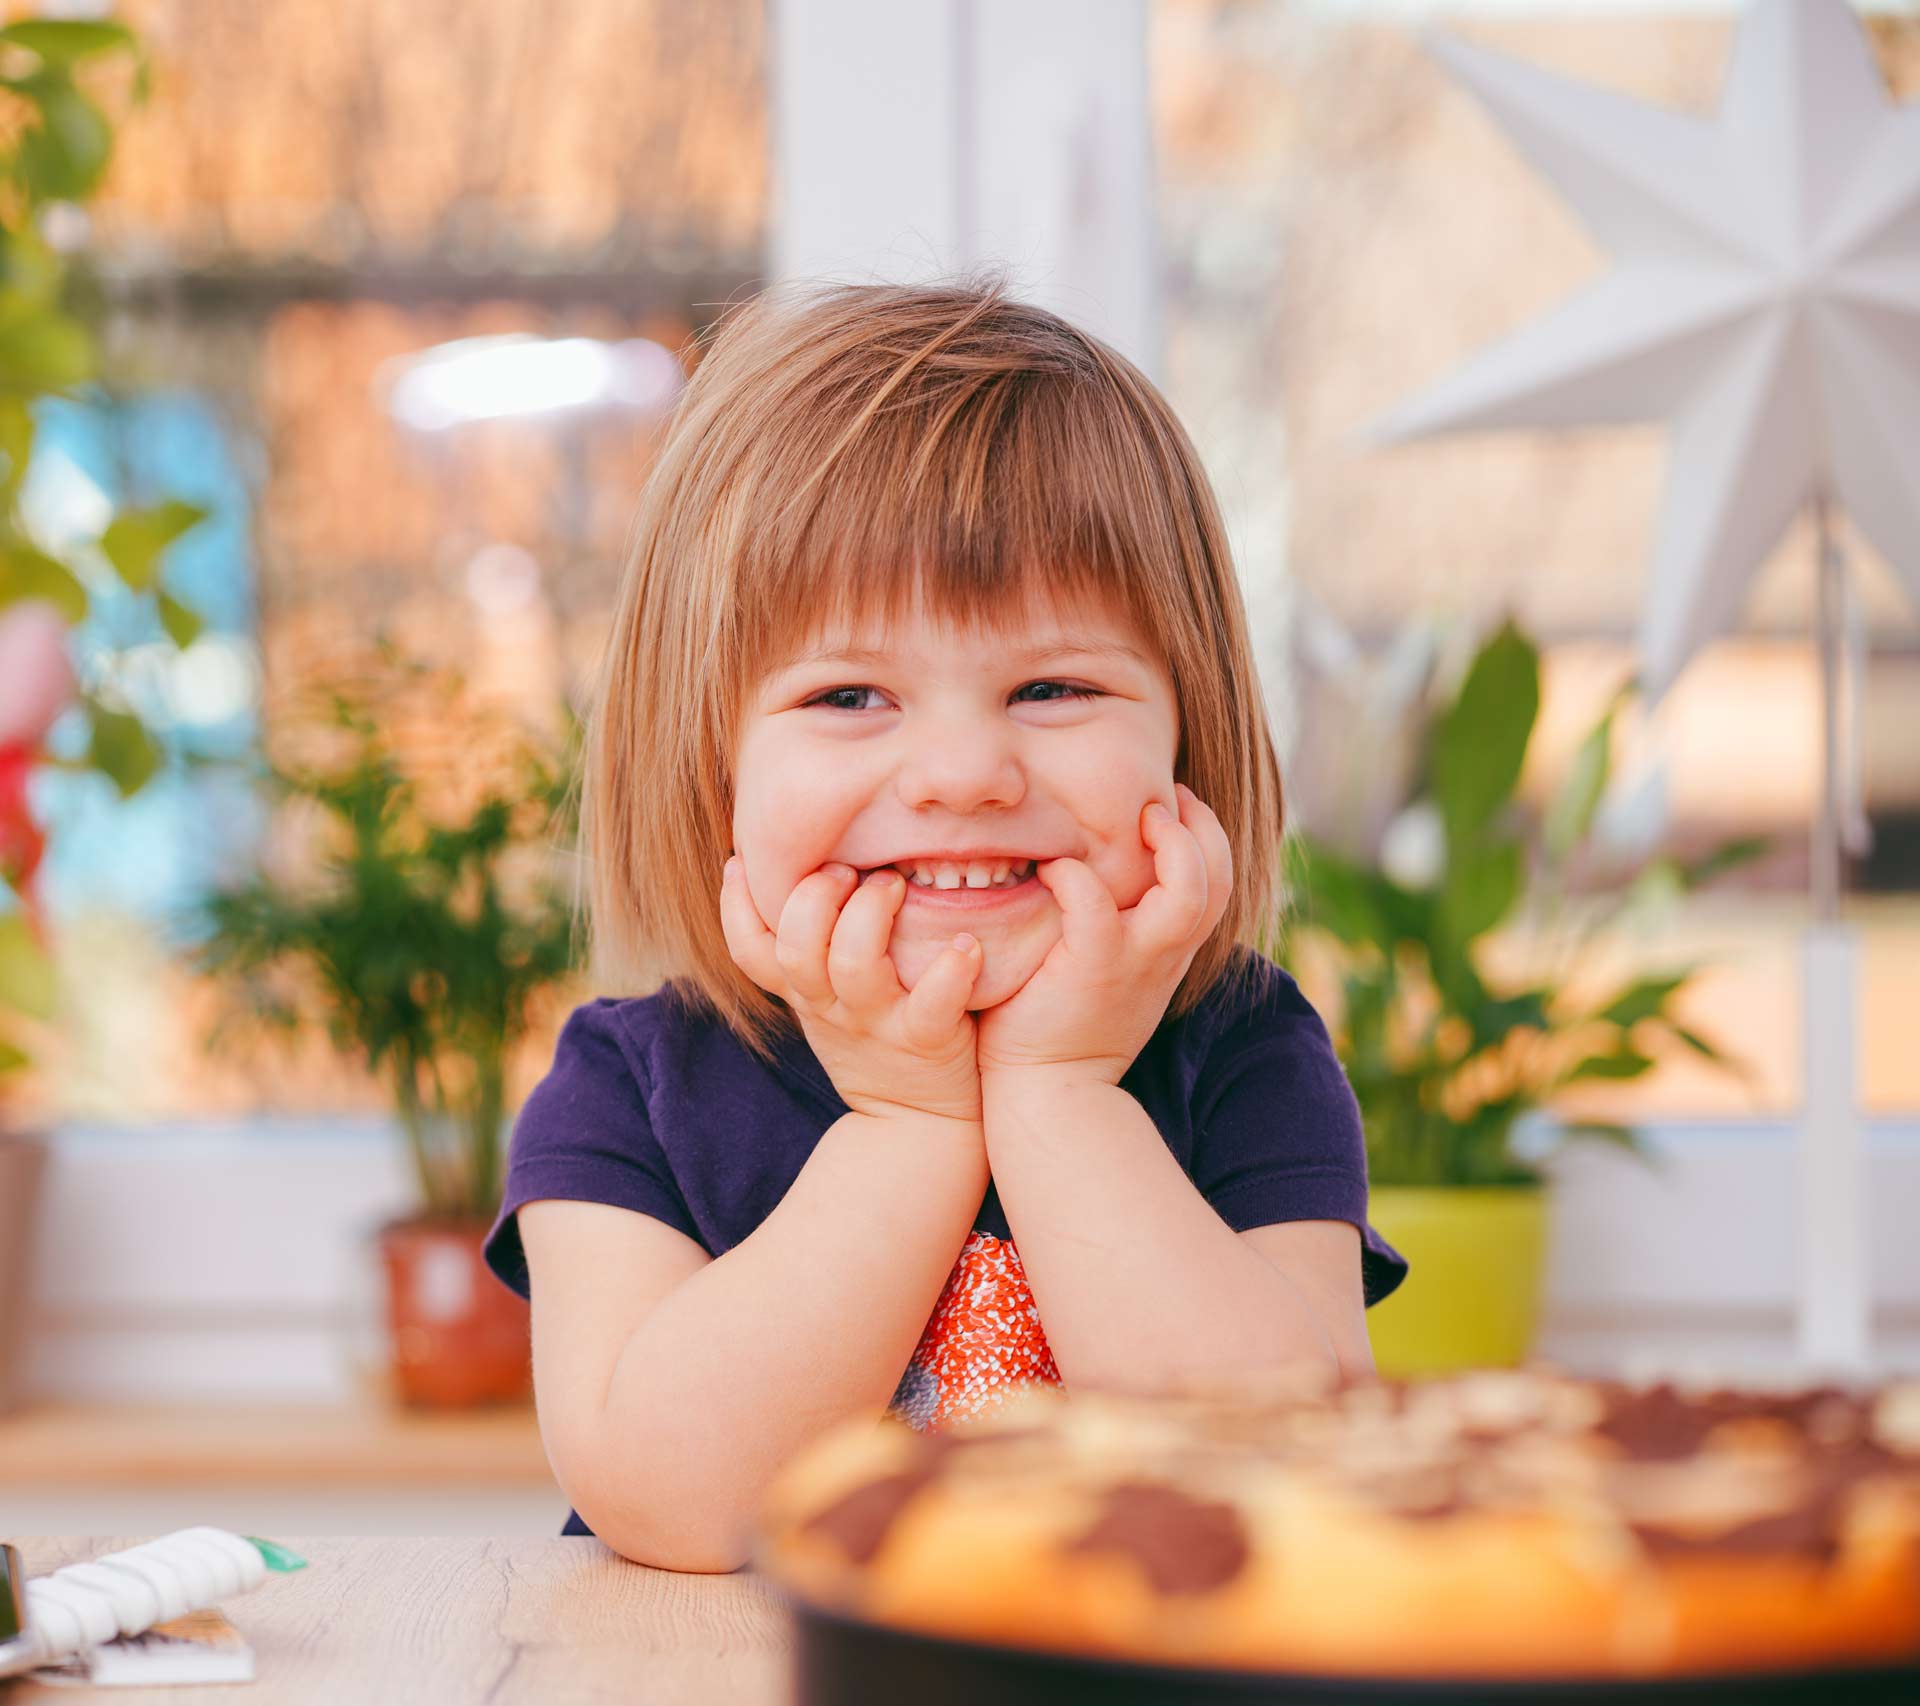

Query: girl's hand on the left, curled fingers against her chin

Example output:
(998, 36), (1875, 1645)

(720, 858), (983, 1125)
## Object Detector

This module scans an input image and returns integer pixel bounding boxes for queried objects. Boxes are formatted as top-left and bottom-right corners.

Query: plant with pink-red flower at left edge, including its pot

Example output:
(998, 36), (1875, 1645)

(0, 17), (218, 1412)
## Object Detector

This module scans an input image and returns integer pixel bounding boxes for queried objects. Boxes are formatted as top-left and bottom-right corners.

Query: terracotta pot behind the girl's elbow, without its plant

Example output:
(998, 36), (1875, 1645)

(378, 1219), (534, 1407)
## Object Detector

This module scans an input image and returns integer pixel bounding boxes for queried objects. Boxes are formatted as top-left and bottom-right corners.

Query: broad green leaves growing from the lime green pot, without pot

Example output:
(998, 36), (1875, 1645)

(1277, 622), (1766, 1186)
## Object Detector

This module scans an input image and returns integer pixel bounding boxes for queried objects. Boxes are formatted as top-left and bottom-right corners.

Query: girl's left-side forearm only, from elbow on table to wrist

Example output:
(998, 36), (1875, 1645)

(593, 1113), (987, 1570)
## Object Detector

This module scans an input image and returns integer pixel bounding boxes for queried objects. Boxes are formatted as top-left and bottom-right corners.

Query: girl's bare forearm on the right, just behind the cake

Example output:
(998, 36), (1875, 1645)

(981, 1077), (1338, 1391)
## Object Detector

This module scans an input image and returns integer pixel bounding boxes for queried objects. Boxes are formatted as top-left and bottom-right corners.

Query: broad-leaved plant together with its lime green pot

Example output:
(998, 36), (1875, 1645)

(1279, 622), (1764, 1374)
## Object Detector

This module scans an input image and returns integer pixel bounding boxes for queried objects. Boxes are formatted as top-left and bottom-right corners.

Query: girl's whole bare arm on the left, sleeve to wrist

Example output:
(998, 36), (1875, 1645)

(520, 1111), (987, 1572)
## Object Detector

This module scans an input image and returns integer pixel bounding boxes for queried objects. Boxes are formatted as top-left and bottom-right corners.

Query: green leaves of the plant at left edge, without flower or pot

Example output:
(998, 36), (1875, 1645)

(0, 17), (205, 1075)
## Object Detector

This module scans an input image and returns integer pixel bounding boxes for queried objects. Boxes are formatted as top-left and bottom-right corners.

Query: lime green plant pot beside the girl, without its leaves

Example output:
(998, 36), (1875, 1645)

(1367, 1184), (1548, 1380)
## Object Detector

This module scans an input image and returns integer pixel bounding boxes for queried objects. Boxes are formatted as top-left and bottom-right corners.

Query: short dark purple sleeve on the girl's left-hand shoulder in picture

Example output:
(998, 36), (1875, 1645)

(484, 996), (701, 1297)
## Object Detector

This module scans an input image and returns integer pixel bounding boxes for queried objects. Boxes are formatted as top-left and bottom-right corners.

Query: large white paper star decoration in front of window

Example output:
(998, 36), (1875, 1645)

(1367, 0), (1920, 700)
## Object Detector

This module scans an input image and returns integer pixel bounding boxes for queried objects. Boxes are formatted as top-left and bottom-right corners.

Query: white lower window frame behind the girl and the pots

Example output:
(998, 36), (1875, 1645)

(15, 1119), (1920, 1405)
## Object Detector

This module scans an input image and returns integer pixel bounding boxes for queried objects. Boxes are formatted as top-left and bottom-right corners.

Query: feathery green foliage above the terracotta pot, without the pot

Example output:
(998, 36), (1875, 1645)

(196, 641), (582, 1220)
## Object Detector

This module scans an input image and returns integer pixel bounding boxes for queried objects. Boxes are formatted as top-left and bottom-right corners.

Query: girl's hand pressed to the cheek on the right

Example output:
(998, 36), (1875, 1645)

(975, 783), (1233, 1084)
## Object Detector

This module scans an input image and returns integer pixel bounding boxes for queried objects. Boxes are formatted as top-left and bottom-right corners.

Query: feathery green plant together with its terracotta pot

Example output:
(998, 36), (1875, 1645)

(194, 639), (580, 1405)
